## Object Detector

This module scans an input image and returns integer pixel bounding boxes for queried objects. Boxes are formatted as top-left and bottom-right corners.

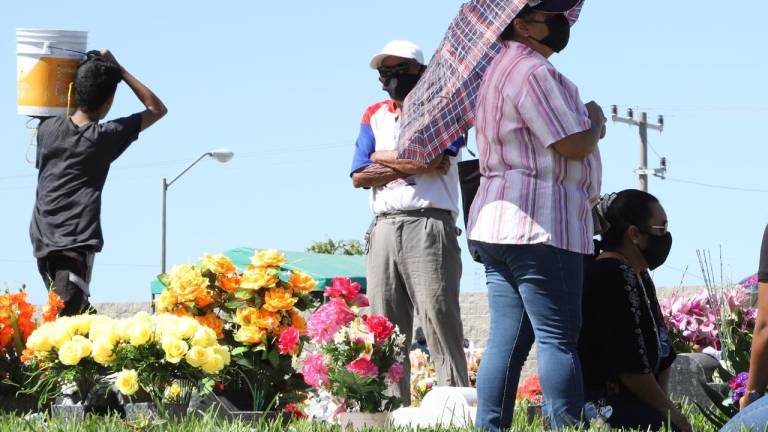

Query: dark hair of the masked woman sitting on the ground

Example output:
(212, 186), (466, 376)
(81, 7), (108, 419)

(600, 189), (659, 250)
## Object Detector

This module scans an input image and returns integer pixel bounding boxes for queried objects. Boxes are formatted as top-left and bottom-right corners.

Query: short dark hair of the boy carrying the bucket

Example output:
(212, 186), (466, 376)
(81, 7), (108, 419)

(75, 57), (123, 113)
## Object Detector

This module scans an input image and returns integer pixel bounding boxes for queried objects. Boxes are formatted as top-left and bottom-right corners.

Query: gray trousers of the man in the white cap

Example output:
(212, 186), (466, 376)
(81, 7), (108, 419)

(366, 209), (469, 405)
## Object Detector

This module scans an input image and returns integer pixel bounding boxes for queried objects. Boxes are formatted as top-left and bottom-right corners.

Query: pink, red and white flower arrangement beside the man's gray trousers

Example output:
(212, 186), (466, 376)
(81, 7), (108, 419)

(302, 278), (405, 413)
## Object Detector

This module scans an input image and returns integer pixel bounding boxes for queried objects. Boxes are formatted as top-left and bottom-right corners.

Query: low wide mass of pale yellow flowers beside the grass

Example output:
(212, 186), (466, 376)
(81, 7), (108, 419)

(21, 313), (230, 404)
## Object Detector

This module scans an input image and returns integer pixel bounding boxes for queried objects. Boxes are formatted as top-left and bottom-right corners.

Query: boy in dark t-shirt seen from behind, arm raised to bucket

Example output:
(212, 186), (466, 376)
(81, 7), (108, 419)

(29, 50), (168, 316)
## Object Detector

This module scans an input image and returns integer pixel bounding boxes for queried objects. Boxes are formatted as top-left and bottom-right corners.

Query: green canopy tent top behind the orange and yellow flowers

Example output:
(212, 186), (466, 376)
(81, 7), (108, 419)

(150, 247), (366, 299)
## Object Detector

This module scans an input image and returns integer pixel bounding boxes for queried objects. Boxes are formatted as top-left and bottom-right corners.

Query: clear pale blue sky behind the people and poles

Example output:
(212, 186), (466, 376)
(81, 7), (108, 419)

(0, 0), (768, 302)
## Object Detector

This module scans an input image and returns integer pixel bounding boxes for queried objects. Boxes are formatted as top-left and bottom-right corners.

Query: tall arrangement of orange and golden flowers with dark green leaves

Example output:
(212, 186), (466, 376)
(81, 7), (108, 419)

(155, 250), (317, 411)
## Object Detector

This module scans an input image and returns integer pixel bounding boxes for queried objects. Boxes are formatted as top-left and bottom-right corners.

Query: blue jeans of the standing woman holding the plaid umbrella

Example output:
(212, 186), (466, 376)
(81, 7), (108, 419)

(475, 242), (584, 432)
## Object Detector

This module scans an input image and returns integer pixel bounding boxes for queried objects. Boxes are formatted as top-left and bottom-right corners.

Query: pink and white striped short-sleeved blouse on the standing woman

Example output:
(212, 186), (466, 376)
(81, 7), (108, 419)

(468, 42), (602, 254)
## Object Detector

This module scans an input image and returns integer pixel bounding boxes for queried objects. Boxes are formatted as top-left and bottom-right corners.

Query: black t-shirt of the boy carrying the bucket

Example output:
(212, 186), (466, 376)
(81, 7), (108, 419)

(29, 114), (141, 258)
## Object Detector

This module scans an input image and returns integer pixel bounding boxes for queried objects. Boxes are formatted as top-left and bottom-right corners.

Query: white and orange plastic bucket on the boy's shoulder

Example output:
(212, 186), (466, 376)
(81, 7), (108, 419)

(16, 29), (88, 116)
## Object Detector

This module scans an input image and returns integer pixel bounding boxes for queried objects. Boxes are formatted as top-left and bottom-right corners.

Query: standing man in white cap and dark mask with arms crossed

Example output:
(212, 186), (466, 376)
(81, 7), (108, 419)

(351, 41), (469, 405)
